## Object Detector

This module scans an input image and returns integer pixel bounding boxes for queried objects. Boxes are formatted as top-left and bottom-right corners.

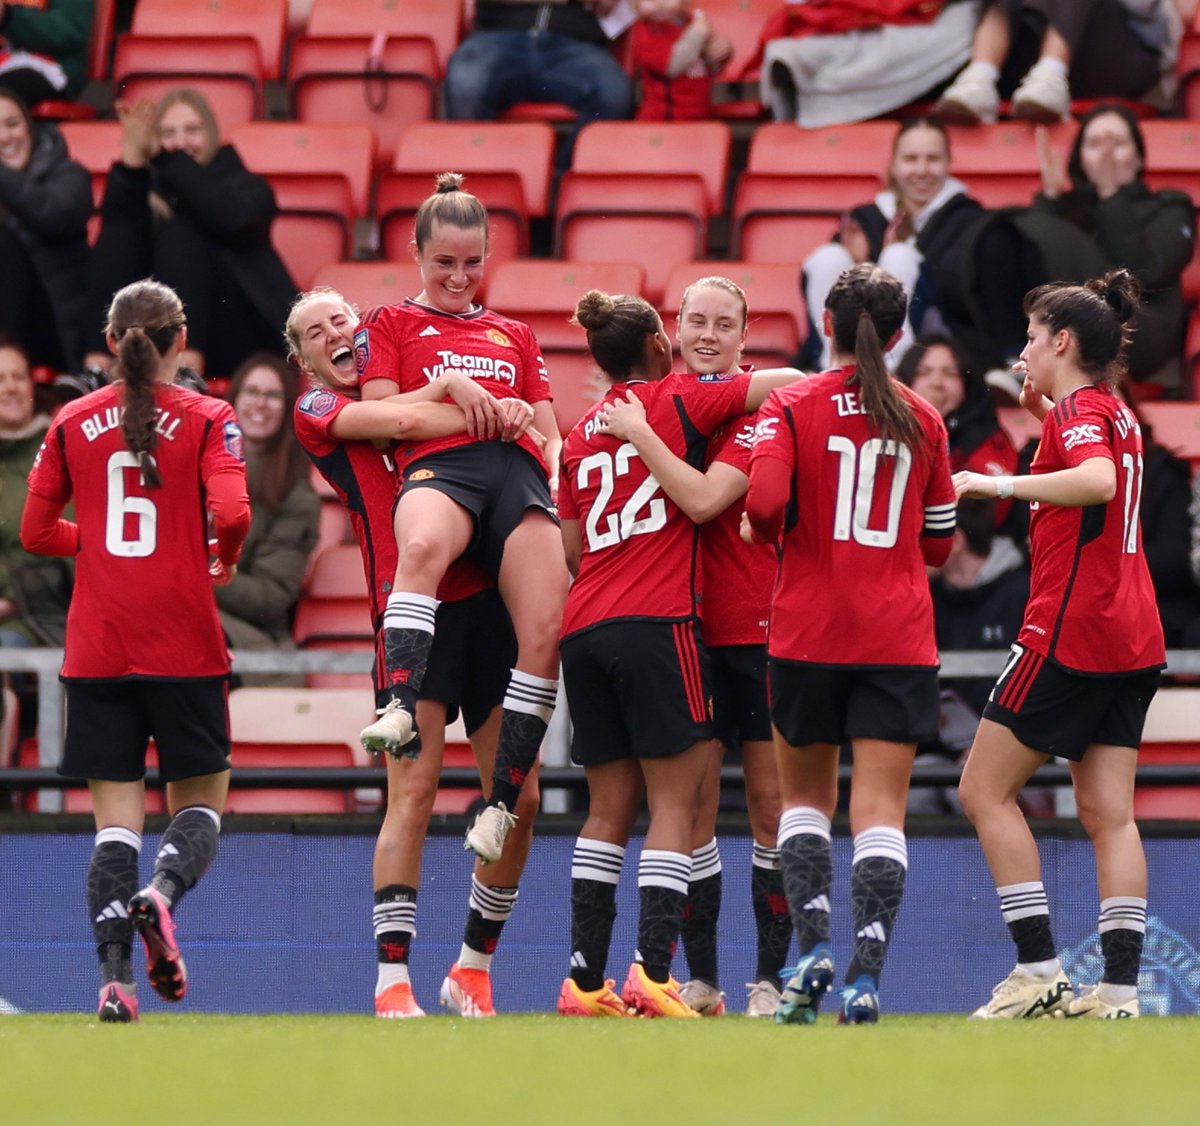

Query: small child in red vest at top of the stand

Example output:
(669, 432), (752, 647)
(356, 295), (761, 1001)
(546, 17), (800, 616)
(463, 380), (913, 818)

(630, 0), (733, 121)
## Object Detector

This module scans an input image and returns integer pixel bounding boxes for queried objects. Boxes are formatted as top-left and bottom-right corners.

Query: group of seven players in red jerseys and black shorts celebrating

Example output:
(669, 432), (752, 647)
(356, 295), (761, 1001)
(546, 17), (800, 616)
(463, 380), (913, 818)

(22, 174), (1165, 1024)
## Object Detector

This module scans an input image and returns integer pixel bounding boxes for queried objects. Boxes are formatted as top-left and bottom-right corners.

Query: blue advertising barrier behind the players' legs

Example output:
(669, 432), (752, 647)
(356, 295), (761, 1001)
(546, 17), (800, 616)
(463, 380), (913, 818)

(0, 819), (1200, 1014)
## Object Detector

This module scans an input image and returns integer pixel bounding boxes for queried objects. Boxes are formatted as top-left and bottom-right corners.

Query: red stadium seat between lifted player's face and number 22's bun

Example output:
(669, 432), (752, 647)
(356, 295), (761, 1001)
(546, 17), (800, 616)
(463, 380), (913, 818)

(487, 258), (646, 350)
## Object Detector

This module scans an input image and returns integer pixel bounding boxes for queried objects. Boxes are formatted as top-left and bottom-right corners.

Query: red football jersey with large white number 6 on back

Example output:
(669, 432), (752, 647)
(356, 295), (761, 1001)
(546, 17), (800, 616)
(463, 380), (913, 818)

(29, 384), (245, 679)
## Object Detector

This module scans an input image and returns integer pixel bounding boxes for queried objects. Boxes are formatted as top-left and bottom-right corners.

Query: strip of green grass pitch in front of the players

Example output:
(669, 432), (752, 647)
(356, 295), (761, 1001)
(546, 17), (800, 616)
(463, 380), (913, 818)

(0, 1013), (1200, 1126)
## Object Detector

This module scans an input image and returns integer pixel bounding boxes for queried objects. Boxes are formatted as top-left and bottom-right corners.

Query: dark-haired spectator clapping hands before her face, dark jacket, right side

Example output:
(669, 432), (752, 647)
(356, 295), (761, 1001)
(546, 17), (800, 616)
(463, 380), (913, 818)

(1033, 104), (1195, 397)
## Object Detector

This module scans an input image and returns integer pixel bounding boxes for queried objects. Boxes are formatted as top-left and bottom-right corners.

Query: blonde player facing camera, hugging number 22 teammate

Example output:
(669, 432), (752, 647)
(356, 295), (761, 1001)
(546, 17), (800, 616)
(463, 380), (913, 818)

(592, 276), (799, 1017)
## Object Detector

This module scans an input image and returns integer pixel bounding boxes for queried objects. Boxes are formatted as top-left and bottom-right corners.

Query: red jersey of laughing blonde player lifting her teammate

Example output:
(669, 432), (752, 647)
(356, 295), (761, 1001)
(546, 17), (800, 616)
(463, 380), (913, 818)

(295, 388), (493, 628)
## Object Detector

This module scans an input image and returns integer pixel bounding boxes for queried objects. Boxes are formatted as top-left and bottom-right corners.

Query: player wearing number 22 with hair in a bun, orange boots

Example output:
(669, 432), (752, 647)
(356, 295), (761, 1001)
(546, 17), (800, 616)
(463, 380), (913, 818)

(558, 289), (796, 1017)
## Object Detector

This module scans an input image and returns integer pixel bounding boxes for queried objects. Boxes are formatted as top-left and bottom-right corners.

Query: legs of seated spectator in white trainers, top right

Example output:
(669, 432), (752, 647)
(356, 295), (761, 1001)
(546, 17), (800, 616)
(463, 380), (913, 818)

(935, 0), (1195, 124)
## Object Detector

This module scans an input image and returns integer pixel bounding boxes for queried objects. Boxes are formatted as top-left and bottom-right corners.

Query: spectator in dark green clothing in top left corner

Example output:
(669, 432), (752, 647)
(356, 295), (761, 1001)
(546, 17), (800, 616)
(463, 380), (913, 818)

(0, 0), (95, 106)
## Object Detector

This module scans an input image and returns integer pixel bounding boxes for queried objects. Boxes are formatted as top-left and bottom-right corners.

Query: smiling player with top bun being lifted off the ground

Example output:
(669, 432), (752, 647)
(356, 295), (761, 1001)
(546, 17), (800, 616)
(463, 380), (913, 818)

(354, 173), (568, 862)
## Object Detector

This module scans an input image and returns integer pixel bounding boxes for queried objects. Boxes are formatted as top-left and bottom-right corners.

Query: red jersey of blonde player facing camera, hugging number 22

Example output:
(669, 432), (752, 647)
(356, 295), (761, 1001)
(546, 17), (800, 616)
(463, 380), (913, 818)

(692, 412), (779, 646)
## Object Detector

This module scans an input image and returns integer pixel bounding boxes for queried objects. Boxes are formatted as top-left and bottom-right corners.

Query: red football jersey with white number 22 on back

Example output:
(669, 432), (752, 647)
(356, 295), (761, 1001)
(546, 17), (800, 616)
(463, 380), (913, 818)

(558, 375), (750, 637)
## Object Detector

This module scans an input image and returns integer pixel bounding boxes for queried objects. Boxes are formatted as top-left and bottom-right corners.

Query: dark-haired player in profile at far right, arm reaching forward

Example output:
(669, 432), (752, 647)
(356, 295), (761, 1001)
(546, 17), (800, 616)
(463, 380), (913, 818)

(954, 270), (1166, 1019)
